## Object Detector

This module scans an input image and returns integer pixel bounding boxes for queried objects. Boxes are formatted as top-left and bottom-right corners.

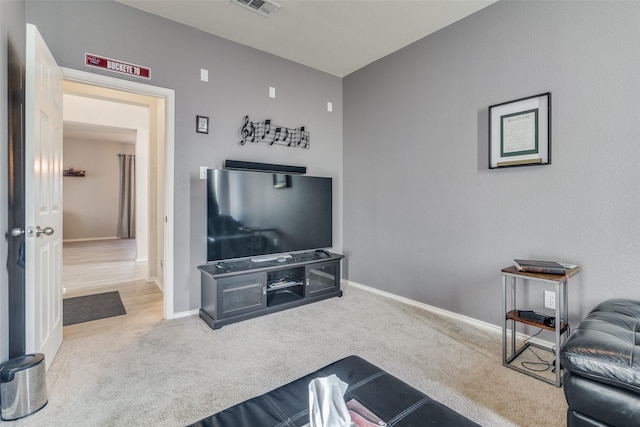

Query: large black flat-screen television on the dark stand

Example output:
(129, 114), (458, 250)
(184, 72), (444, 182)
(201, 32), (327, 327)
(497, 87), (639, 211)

(207, 169), (333, 262)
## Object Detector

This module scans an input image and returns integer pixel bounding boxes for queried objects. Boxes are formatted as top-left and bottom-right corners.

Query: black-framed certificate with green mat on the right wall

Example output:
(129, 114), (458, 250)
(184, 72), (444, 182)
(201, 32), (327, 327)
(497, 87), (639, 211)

(489, 92), (551, 169)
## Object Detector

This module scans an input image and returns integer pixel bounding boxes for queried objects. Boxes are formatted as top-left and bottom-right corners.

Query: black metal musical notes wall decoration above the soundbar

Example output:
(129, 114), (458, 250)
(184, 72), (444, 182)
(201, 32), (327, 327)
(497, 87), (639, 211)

(239, 116), (309, 148)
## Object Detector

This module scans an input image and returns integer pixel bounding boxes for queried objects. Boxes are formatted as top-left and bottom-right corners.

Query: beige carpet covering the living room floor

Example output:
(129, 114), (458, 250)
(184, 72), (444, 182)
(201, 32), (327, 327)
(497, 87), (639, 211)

(13, 286), (566, 427)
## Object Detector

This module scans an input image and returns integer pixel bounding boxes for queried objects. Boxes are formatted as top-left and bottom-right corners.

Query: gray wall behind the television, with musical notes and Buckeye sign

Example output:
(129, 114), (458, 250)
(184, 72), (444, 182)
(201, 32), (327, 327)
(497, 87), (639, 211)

(26, 1), (342, 312)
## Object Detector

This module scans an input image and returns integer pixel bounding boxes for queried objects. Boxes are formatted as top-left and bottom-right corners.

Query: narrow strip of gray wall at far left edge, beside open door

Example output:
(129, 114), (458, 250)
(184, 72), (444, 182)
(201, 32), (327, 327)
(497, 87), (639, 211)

(0, 1), (26, 362)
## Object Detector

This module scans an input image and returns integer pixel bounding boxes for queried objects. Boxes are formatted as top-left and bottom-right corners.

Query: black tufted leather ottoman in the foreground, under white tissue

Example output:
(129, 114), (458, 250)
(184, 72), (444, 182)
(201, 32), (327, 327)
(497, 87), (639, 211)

(192, 356), (479, 427)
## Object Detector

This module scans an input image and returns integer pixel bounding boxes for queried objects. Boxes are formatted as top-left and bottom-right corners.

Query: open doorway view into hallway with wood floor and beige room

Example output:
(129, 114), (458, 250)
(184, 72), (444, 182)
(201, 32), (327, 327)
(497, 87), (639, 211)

(62, 82), (159, 339)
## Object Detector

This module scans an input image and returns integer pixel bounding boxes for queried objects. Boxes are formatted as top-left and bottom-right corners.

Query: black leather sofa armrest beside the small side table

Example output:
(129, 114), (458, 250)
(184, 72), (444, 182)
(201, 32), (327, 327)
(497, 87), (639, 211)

(560, 299), (640, 427)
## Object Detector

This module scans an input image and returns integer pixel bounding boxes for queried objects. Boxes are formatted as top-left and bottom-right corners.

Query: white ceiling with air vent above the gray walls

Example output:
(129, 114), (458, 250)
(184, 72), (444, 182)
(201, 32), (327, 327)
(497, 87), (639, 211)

(117, 0), (495, 77)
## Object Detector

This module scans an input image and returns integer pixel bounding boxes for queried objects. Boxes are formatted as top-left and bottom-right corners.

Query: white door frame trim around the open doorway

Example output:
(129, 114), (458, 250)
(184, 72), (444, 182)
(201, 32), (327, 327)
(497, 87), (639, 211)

(60, 67), (175, 319)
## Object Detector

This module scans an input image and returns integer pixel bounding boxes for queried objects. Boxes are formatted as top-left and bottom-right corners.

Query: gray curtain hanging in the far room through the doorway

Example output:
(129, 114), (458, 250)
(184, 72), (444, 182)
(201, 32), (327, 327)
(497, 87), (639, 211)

(118, 154), (136, 239)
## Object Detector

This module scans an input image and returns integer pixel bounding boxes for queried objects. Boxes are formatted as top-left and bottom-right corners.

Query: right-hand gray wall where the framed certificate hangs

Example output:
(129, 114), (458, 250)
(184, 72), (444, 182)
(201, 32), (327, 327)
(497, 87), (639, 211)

(343, 1), (640, 325)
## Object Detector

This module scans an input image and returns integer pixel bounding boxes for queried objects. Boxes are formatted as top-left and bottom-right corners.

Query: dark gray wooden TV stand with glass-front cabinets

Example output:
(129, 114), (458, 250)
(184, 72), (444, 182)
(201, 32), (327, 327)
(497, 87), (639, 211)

(198, 251), (344, 329)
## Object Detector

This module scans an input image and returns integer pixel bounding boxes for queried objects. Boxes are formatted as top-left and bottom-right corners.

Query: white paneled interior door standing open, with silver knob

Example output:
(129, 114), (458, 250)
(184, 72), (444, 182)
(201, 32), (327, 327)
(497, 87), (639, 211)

(25, 24), (63, 368)
